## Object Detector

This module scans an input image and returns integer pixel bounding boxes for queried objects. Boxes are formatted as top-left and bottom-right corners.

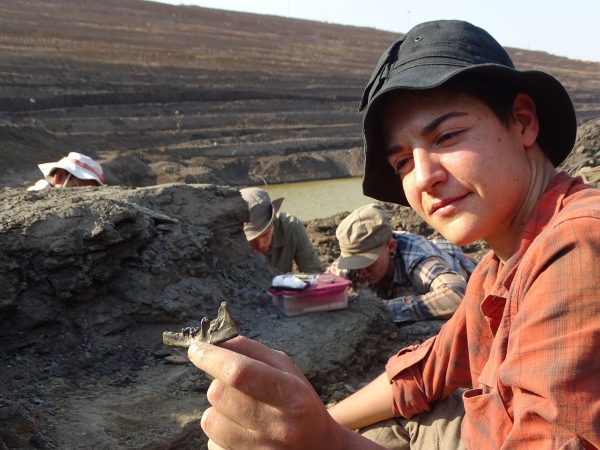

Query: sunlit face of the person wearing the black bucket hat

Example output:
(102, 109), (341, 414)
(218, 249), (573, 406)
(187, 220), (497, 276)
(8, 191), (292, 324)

(381, 91), (530, 245)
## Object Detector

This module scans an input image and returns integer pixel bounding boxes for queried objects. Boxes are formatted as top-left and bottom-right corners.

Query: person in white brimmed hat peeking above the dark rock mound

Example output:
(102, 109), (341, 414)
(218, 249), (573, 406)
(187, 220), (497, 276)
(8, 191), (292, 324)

(27, 152), (104, 191)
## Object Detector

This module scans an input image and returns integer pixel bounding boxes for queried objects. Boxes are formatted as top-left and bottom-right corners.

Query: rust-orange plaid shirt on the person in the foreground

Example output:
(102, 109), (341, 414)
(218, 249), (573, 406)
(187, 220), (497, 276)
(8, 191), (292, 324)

(386, 173), (600, 450)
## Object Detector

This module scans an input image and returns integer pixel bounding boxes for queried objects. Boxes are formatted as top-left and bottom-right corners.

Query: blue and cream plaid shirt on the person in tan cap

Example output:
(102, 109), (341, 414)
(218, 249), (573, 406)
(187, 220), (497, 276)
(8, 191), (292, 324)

(328, 231), (475, 323)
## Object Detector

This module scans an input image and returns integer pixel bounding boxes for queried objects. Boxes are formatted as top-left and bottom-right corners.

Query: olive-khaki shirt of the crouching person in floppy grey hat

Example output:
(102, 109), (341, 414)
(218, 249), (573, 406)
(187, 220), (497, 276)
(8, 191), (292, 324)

(265, 212), (323, 273)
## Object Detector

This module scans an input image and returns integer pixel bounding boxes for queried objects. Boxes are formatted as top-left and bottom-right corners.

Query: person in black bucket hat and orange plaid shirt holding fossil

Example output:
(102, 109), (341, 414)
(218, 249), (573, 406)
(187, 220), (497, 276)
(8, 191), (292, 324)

(188, 20), (600, 450)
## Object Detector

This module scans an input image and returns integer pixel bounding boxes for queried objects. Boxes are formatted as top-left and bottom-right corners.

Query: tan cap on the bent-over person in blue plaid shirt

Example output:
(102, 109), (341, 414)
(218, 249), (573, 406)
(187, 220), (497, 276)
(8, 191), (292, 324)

(335, 203), (392, 269)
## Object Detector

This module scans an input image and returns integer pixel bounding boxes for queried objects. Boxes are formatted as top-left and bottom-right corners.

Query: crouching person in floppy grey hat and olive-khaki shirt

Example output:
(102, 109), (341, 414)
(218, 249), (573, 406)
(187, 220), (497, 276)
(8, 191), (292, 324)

(240, 187), (323, 273)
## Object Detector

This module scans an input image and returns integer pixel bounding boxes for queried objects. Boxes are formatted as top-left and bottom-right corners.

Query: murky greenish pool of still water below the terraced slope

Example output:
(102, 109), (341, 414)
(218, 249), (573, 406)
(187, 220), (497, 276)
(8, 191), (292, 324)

(257, 177), (375, 221)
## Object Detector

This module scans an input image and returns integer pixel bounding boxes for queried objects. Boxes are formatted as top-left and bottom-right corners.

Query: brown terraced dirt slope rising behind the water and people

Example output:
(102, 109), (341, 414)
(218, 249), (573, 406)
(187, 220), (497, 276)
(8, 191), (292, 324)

(0, 0), (600, 186)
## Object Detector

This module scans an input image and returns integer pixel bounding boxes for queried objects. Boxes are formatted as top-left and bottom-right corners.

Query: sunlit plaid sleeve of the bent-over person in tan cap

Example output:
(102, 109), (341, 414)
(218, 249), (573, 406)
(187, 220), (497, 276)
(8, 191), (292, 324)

(386, 256), (467, 323)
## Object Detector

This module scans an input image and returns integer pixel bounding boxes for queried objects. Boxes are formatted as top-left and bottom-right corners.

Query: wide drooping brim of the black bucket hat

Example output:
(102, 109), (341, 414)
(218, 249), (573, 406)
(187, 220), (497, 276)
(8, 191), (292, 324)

(363, 61), (577, 206)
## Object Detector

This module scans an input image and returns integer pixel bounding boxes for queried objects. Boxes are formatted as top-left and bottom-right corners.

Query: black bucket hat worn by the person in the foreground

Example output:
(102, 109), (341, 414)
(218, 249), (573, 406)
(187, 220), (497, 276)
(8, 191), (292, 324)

(359, 20), (577, 205)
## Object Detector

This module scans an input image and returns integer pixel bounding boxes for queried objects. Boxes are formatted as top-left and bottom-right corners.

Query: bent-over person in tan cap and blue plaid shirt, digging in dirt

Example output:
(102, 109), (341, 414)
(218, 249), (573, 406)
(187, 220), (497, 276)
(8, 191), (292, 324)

(328, 203), (475, 324)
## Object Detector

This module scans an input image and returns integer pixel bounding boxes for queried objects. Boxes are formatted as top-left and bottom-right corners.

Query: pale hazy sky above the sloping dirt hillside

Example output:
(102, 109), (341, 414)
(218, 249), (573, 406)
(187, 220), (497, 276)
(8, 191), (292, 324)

(154, 0), (600, 62)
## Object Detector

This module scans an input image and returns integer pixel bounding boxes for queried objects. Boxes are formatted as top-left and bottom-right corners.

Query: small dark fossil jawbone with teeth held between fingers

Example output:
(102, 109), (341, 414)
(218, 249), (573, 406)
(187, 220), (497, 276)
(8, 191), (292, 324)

(163, 302), (239, 348)
